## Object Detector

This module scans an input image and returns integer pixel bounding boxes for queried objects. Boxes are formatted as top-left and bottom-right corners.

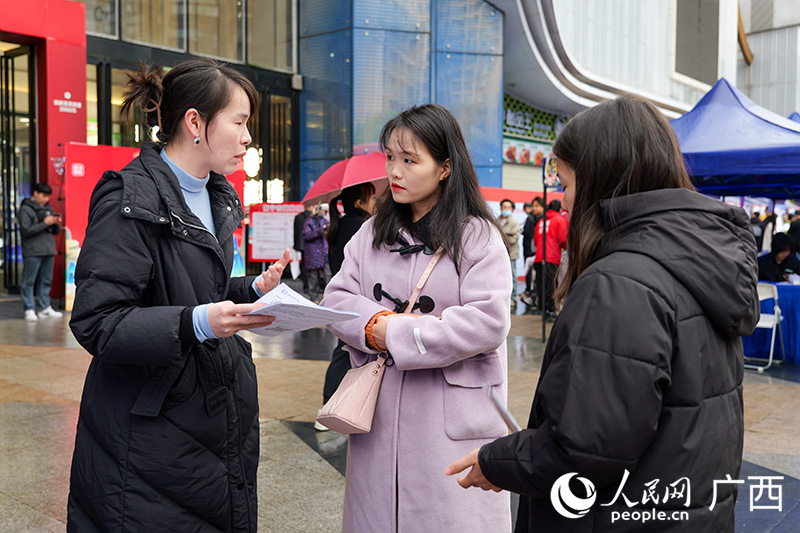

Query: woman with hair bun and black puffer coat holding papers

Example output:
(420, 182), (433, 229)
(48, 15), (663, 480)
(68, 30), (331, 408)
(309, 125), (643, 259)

(67, 59), (290, 533)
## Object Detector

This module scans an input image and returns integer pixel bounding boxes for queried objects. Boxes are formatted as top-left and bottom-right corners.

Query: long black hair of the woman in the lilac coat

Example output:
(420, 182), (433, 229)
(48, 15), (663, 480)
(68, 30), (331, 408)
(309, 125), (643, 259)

(372, 104), (499, 270)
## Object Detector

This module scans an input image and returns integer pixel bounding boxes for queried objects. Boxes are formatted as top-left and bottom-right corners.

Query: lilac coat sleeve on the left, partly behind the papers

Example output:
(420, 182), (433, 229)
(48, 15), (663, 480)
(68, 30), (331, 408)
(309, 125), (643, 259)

(320, 223), (389, 354)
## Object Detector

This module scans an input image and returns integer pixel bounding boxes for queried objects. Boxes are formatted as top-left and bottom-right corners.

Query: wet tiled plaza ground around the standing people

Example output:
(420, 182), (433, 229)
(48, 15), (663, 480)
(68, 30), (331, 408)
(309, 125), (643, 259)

(0, 294), (800, 533)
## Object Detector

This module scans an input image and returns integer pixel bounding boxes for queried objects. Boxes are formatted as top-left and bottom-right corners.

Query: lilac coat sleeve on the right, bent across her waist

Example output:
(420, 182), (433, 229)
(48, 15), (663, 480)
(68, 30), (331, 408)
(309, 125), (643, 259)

(386, 220), (511, 370)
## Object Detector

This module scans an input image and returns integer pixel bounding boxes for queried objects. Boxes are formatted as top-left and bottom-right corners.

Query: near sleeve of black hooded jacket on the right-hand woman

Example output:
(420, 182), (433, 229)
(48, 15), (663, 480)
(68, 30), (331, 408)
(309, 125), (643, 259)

(479, 273), (675, 497)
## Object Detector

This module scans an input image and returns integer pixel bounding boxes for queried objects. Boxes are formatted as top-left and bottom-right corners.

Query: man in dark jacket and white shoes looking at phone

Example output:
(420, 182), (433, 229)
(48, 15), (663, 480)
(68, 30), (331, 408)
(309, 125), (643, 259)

(17, 183), (64, 321)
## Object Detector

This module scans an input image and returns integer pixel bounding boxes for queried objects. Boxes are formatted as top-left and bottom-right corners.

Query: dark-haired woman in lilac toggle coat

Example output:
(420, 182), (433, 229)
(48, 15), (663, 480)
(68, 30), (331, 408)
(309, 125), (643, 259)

(323, 104), (511, 533)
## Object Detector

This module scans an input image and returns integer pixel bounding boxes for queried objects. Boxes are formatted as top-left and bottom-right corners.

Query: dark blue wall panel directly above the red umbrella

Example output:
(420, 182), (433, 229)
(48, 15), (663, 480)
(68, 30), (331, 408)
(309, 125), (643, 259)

(300, 31), (352, 197)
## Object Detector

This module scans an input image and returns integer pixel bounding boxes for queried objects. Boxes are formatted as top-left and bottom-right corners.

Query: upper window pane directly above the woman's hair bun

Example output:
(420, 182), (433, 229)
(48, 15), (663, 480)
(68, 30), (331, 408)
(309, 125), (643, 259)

(121, 0), (186, 50)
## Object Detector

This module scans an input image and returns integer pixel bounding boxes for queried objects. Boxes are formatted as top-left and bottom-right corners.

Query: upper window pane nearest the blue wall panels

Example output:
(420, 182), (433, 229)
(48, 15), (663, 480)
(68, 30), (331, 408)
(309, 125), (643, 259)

(247, 0), (293, 72)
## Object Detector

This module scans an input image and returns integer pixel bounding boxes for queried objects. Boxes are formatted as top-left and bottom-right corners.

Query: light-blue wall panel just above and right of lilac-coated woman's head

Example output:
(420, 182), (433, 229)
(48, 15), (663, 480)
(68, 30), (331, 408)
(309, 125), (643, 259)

(436, 52), (503, 185)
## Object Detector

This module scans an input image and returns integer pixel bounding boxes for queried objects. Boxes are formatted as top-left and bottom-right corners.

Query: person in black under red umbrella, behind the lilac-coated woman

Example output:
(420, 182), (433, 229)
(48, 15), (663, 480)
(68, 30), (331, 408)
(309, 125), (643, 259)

(314, 183), (375, 431)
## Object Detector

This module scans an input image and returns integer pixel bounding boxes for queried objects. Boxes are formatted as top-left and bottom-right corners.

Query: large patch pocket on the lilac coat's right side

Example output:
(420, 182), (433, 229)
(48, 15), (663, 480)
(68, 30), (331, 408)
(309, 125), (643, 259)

(442, 356), (507, 440)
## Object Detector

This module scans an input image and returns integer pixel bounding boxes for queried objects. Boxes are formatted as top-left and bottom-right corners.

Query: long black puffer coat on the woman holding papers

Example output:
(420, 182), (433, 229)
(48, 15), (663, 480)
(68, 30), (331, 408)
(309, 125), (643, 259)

(67, 144), (259, 533)
